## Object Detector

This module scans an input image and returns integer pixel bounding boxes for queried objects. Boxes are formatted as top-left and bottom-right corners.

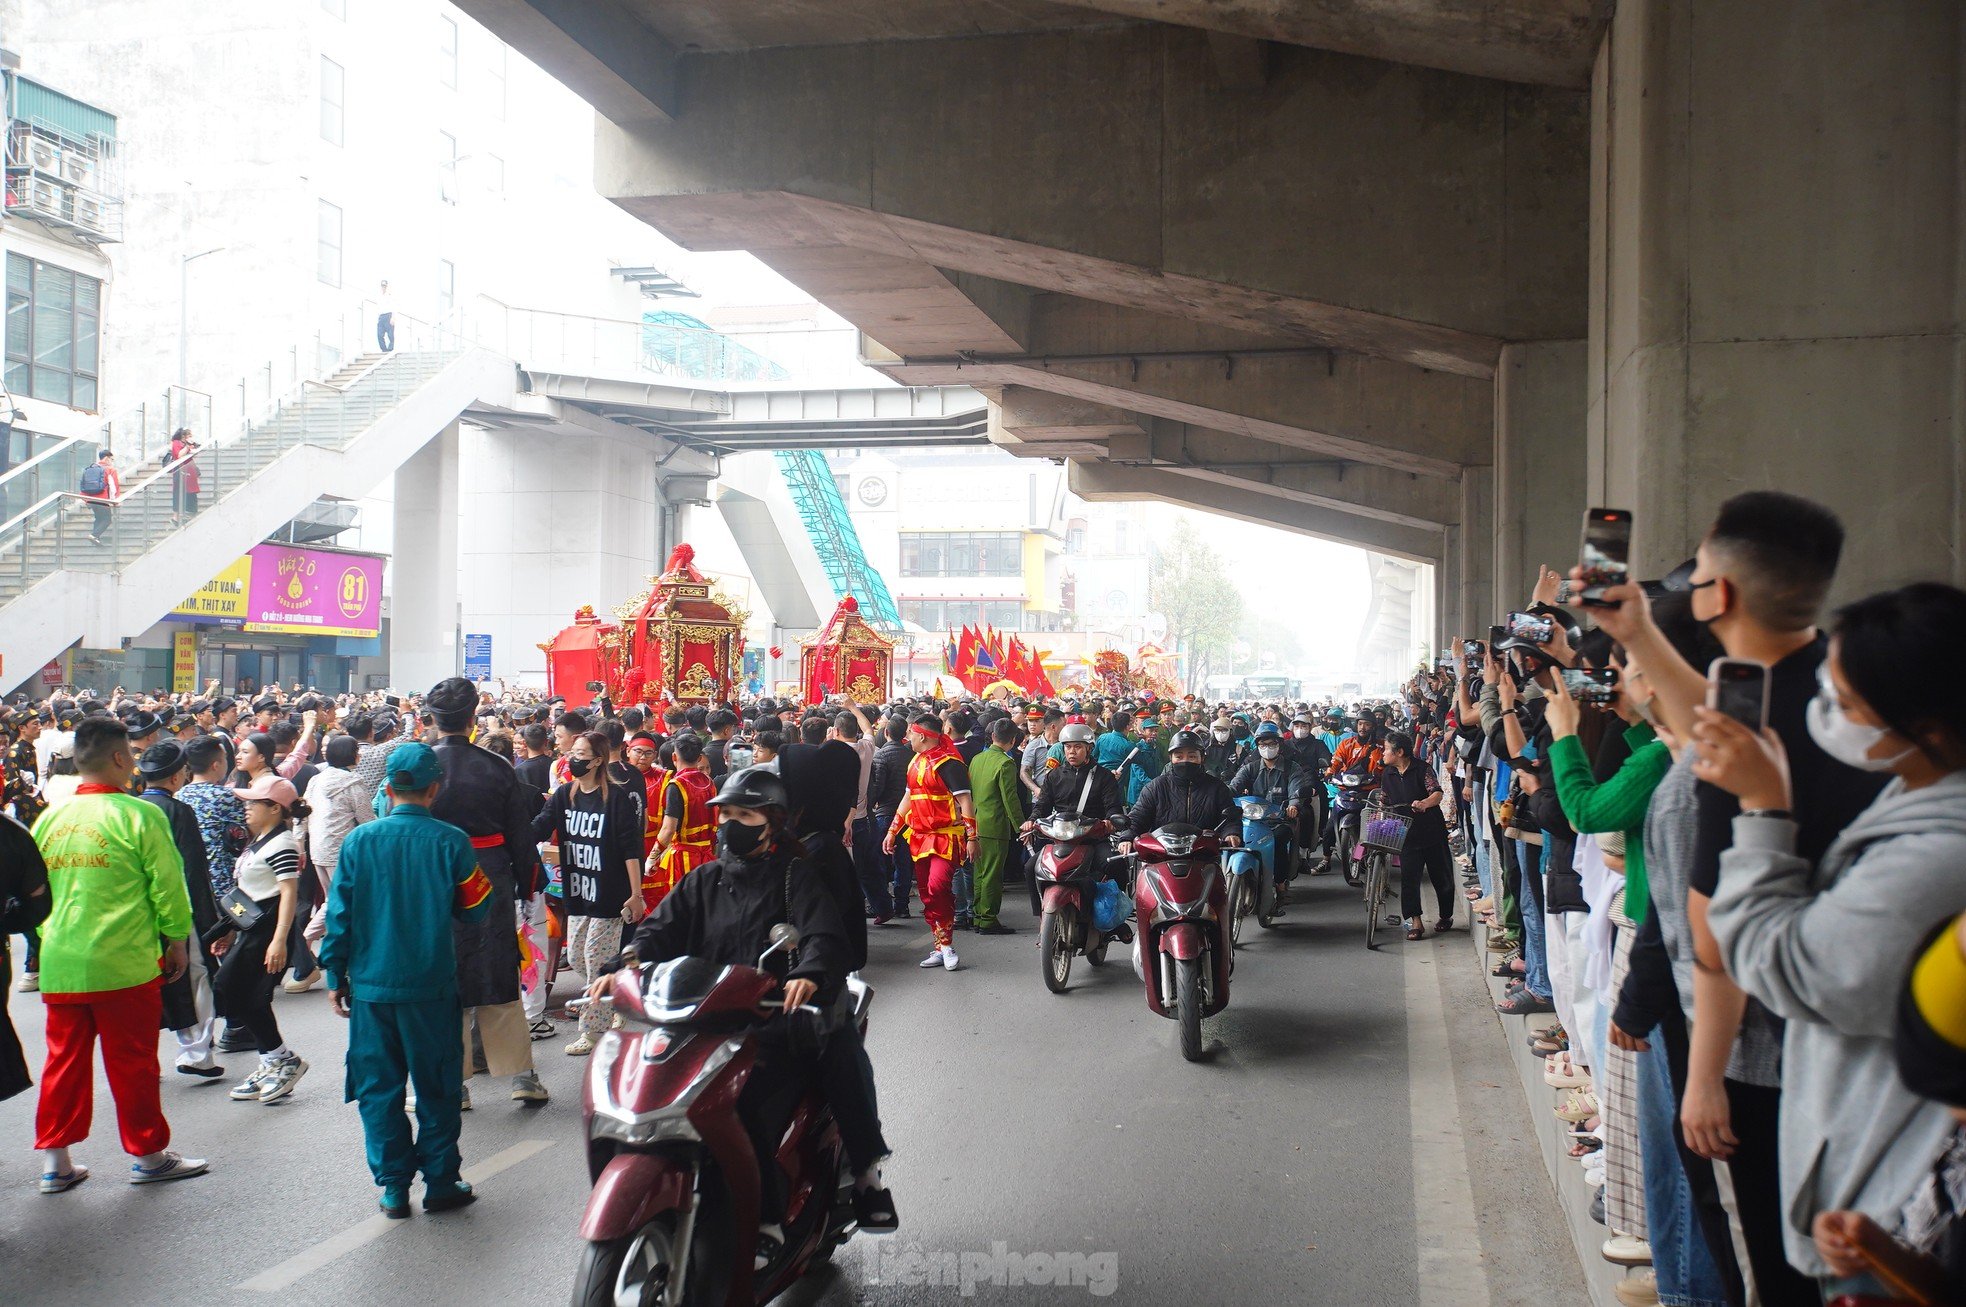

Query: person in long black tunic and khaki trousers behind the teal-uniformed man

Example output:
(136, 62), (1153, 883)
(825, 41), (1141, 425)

(423, 676), (547, 1103)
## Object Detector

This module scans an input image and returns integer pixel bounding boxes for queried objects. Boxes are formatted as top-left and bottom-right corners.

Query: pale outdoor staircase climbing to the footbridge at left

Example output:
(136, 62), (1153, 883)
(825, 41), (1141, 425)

(0, 348), (517, 688)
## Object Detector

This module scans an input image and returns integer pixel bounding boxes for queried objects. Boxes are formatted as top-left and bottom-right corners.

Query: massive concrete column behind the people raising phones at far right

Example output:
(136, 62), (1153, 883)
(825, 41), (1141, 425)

(1588, 0), (1966, 597)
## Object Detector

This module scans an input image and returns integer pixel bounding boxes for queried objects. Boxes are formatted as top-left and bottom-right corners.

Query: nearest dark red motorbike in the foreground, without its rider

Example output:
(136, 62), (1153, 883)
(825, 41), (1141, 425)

(574, 926), (873, 1307)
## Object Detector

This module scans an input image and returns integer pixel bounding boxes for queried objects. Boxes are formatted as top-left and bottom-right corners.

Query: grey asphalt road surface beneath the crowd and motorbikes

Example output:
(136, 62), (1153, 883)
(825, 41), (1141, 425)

(0, 864), (1587, 1307)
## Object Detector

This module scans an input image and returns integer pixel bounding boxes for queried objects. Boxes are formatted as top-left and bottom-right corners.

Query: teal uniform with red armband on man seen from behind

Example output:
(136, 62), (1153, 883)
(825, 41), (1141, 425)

(318, 804), (493, 1191)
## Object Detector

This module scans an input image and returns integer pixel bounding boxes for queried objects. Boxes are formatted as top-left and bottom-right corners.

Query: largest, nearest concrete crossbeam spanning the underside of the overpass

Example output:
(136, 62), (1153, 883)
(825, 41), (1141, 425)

(596, 28), (1589, 377)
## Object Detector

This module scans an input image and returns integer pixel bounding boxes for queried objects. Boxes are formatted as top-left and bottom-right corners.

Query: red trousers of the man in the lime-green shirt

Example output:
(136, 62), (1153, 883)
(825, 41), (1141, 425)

(33, 981), (171, 1158)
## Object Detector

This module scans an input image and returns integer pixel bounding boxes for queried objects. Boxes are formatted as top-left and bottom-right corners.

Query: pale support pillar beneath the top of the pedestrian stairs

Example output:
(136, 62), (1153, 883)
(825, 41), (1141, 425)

(389, 423), (458, 694)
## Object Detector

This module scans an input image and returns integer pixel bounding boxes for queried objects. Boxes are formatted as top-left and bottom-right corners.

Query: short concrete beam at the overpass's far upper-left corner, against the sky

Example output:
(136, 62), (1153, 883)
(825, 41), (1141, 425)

(458, 0), (676, 124)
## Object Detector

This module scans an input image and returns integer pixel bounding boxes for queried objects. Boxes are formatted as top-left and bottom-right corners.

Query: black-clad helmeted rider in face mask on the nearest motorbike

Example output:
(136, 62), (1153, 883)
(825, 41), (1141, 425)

(588, 767), (898, 1242)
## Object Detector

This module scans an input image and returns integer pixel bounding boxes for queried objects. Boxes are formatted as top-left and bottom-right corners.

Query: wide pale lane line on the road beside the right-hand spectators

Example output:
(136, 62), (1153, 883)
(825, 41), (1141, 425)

(1406, 943), (1492, 1307)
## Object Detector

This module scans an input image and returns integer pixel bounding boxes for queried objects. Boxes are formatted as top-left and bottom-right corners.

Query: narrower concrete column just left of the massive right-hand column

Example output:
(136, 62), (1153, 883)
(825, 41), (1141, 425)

(1494, 340), (1589, 609)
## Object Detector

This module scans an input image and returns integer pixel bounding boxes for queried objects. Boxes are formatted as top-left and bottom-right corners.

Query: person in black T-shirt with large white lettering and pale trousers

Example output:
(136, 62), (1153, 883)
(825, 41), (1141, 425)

(533, 731), (643, 1057)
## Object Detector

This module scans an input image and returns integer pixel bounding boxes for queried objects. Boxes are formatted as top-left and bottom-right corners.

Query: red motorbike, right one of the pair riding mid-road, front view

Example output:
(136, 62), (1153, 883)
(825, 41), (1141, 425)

(1132, 822), (1235, 1061)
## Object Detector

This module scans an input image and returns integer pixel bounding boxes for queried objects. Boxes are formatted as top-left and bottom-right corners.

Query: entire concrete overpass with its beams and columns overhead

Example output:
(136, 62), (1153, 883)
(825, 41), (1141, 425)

(460, 0), (1966, 631)
